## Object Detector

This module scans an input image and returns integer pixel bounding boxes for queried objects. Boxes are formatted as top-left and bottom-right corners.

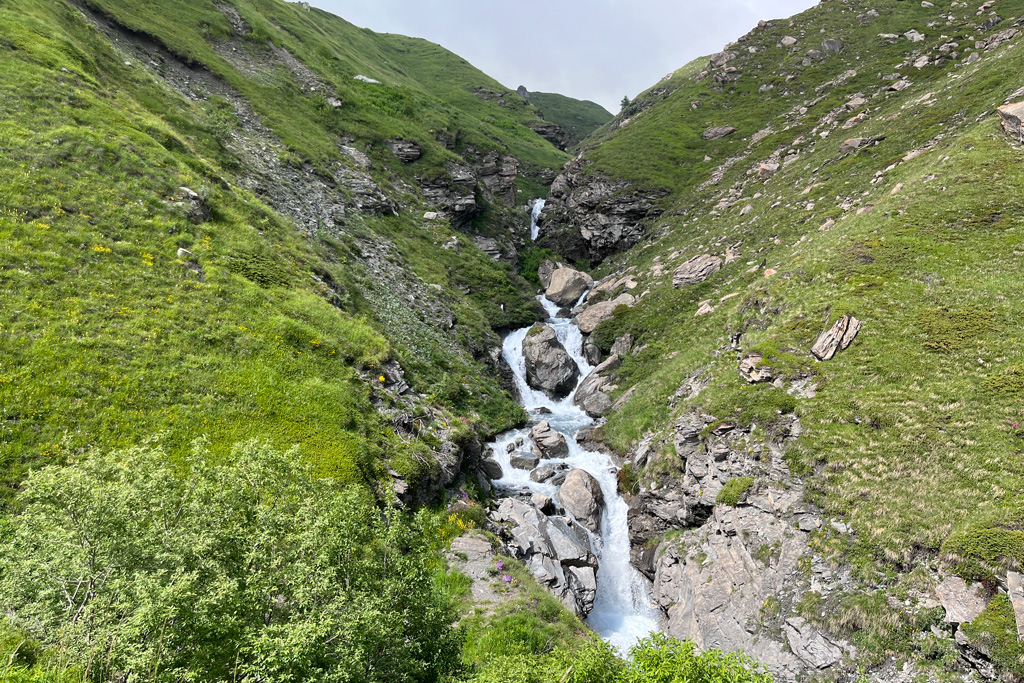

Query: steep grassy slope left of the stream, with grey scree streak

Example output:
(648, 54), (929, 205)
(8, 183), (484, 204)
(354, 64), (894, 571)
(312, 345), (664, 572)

(0, 0), (577, 495)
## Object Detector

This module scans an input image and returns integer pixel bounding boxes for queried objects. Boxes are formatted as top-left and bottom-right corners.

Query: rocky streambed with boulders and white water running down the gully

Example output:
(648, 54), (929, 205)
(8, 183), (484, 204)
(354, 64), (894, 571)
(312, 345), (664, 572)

(484, 294), (659, 652)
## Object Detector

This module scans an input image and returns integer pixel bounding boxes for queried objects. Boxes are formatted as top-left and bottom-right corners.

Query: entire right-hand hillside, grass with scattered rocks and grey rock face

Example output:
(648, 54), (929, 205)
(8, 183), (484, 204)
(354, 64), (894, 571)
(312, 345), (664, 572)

(542, 0), (1024, 680)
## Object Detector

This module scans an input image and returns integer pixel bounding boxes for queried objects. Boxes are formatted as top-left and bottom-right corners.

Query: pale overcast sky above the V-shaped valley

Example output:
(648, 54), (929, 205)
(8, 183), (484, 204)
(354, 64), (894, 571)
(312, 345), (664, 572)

(312, 0), (815, 113)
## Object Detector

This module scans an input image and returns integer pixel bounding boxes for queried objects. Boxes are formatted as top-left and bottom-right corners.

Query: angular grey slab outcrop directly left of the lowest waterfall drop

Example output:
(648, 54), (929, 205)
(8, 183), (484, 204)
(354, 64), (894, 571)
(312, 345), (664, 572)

(492, 498), (597, 617)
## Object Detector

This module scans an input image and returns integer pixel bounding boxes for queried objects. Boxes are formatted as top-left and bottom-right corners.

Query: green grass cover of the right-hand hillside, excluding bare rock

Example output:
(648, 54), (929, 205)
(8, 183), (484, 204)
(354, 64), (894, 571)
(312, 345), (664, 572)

(548, 0), (1024, 680)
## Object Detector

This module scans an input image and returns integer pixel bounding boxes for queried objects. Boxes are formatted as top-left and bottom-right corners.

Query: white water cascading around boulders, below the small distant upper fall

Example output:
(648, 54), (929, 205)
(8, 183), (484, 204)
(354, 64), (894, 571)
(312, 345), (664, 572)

(494, 294), (658, 654)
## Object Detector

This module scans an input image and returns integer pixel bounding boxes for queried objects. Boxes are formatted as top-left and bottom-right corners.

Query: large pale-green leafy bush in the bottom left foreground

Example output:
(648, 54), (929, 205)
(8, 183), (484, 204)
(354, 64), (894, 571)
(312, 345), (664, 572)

(0, 443), (459, 682)
